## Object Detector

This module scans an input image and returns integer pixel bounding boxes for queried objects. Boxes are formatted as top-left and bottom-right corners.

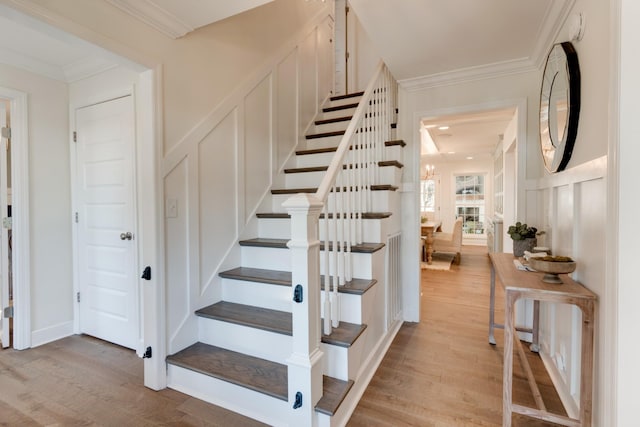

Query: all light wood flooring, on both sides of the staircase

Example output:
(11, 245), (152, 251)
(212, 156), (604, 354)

(0, 247), (559, 427)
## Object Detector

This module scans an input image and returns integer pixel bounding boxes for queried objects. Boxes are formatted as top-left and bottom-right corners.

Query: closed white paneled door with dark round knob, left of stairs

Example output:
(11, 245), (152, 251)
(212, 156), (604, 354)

(76, 96), (140, 349)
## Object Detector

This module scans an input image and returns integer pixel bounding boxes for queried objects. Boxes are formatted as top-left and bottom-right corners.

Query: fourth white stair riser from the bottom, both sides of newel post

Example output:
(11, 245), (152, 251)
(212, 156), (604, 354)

(242, 246), (373, 279)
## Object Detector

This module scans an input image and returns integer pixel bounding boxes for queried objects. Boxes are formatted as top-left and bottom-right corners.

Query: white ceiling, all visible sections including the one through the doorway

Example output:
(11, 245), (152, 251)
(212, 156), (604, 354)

(0, 0), (575, 161)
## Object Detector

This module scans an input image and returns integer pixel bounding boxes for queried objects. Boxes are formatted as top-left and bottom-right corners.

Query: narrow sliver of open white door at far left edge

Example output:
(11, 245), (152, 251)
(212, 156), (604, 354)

(0, 100), (11, 348)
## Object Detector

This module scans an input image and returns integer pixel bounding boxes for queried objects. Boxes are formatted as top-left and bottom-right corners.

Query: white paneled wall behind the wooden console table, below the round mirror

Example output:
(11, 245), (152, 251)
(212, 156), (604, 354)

(527, 157), (607, 416)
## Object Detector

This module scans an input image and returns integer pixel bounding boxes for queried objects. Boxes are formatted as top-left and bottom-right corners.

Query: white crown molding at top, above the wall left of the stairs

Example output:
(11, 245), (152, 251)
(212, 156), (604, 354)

(106, 0), (195, 39)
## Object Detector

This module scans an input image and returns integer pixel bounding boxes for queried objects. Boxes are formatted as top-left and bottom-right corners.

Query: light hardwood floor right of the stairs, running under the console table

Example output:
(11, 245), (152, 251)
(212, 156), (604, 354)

(348, 246), (564, 427)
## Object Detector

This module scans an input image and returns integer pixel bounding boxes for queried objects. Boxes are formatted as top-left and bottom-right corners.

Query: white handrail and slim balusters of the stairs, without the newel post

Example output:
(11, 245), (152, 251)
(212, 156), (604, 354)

(315, 62), (396, 335)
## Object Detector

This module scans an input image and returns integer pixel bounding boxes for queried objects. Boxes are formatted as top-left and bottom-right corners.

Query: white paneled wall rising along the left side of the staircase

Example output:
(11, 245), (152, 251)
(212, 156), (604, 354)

(163, 16), (333, 354)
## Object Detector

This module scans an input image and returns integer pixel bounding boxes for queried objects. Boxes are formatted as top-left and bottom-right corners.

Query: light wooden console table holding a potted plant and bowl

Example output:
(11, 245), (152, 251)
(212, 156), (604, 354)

(489, 253), (597, 427)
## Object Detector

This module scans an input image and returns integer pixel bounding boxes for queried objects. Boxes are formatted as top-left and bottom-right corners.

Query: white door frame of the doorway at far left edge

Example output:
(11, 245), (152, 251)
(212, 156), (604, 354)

(0, 87), (31, 350)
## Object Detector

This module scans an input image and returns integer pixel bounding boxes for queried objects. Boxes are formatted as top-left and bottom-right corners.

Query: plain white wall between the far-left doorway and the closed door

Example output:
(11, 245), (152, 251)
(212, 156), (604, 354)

(0, 64), (73, 345)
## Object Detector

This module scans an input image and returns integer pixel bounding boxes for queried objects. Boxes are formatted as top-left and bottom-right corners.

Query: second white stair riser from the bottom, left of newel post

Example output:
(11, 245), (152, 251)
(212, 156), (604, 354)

(198, 317), (291, 364)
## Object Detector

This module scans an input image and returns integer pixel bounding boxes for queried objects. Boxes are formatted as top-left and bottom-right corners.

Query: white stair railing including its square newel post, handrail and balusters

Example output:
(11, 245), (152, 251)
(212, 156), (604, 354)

(283, 62), (397, 425)
